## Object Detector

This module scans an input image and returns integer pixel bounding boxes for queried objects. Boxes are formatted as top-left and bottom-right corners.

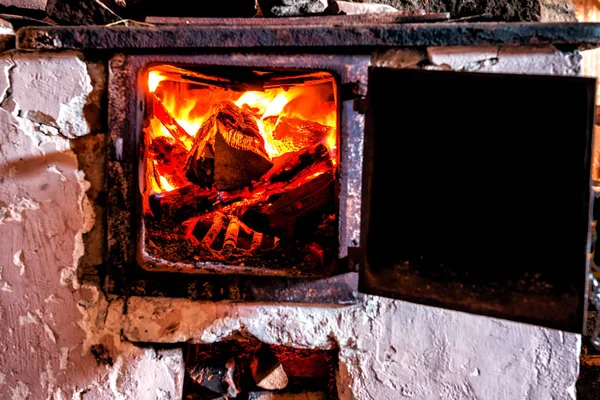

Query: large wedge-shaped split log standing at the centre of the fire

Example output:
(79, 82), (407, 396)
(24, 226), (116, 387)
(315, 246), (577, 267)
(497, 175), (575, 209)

(185, 101), (273, 191)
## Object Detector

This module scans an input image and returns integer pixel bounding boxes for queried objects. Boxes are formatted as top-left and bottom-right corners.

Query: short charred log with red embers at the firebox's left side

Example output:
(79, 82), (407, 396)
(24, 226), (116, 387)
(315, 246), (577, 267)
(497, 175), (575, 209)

(148, 185), (217, 224)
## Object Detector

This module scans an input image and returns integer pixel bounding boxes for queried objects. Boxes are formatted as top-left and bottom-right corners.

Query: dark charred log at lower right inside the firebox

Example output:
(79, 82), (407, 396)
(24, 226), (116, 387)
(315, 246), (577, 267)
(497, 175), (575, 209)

(242, 171), (335, 238)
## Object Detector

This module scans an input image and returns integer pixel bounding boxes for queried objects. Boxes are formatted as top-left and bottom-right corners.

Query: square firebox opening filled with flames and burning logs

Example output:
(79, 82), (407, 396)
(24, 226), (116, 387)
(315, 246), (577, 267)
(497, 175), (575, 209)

(140, 64), (339, 276)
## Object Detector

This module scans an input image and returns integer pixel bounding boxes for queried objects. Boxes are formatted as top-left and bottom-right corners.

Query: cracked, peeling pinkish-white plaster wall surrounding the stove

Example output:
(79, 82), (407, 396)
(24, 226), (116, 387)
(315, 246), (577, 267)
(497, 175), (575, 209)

(0, 48), (581, 400)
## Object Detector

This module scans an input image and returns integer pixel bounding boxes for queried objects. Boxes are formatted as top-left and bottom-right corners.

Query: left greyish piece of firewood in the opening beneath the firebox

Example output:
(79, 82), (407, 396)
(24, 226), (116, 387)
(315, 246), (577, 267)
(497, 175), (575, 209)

(188, 358), (240, 397)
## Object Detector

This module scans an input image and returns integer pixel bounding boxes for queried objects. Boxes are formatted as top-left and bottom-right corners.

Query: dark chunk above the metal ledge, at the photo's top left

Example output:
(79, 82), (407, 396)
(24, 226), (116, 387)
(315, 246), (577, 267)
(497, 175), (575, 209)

(46, 0), (123, 25)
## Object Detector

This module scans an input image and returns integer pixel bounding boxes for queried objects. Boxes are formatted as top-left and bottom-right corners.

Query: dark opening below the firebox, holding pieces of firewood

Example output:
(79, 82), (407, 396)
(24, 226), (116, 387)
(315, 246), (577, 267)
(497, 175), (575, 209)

(183, 338), (339, 400)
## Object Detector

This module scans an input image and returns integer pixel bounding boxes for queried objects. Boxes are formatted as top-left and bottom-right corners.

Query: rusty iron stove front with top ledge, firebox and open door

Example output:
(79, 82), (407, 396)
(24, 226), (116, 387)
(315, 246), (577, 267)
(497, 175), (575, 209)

(18, 21), (584, 332)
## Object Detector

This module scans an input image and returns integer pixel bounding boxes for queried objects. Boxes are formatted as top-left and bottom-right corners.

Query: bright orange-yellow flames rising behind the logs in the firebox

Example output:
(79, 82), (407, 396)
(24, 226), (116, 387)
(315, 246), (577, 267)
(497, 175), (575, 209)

(145, 66), (338, 197)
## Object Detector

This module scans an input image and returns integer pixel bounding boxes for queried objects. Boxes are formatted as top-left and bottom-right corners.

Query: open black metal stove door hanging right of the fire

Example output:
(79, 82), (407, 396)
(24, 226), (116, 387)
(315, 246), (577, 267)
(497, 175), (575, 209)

(357, 68), (595, 332)
